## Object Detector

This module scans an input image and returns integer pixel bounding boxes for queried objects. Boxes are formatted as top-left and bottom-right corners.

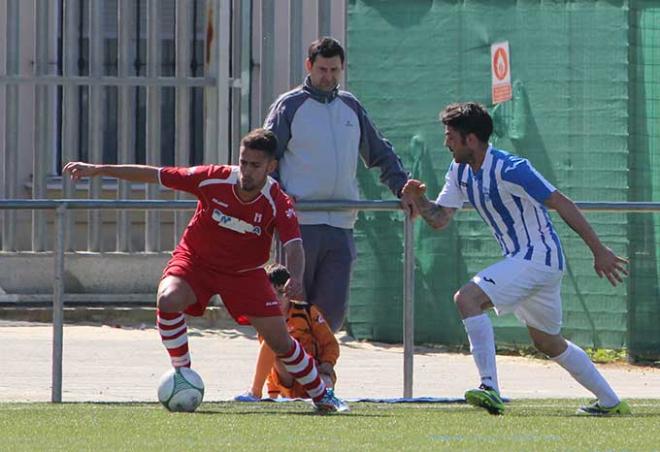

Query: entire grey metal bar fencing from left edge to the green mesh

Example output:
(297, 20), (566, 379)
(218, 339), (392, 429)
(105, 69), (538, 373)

(0, 0), (345, 252)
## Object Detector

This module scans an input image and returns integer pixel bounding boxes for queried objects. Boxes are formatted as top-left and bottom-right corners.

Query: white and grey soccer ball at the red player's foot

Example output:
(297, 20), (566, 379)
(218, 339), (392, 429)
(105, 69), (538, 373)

(158, 367), (204, 413)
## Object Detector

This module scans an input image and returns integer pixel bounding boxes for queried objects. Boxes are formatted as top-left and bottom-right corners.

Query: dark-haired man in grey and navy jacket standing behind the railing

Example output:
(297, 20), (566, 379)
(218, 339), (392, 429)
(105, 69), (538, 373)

(264, 37), (414, 331)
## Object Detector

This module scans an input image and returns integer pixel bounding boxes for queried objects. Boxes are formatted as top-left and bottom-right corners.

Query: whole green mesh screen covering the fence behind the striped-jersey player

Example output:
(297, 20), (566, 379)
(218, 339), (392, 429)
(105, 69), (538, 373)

(347, 0), (660, 355)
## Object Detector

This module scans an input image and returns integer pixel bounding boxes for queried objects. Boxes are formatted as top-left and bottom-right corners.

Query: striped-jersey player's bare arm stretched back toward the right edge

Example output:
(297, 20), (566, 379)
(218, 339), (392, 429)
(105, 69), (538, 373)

(545, 190), (628, 286)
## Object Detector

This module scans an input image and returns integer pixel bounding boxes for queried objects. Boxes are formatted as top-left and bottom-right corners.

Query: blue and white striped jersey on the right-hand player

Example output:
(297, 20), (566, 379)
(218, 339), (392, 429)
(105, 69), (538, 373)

(435, 146), (564, 270)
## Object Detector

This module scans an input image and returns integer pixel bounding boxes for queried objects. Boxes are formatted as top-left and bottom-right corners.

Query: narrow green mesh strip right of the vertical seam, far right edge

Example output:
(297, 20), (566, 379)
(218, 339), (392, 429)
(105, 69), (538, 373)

(628, 1), (660, 359)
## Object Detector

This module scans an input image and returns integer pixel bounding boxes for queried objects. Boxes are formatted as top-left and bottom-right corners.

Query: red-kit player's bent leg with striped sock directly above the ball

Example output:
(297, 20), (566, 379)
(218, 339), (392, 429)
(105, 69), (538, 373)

(156, 276), (196, 368)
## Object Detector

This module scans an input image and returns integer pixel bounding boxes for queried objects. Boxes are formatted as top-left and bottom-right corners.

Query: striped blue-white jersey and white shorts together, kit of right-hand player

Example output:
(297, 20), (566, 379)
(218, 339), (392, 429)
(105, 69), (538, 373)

(435, 145), (564, 340)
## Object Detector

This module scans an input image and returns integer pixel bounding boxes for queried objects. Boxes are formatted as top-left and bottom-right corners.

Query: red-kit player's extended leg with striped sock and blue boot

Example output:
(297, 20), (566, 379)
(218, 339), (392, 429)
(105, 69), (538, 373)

(250, 316), (348, 412)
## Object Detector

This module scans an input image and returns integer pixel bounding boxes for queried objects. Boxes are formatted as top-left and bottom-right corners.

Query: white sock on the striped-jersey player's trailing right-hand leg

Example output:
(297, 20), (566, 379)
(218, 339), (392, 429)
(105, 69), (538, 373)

(550, 341), (620, 408)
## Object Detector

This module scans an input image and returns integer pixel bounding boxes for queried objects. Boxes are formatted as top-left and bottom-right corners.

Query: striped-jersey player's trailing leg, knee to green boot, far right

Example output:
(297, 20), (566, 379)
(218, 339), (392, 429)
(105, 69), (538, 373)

(527, 326), (630, 415)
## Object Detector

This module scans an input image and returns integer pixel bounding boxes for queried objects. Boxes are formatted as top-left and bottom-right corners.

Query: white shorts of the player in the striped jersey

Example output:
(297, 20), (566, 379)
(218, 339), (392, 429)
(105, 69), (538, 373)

(472, 258), (564, 334)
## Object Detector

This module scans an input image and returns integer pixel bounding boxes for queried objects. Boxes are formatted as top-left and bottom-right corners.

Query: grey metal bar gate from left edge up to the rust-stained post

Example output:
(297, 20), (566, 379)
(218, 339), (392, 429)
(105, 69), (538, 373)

(0, 0), (232, 251)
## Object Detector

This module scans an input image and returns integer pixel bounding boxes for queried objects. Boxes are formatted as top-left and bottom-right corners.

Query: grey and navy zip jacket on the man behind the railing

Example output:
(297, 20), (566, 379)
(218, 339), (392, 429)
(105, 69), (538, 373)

(264, 77), (408, 229)
